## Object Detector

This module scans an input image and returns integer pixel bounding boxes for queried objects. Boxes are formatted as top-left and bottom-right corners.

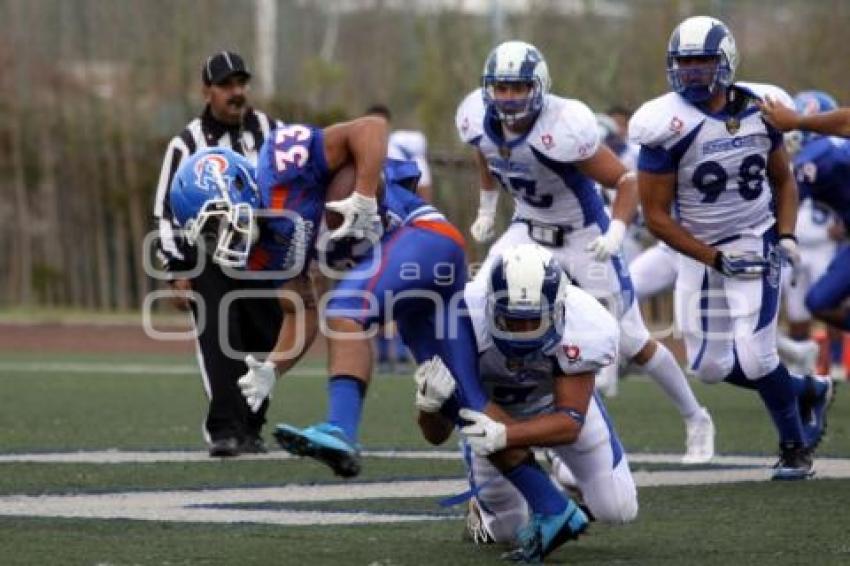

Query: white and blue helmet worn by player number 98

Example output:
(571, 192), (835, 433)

(667, 16), (738, 104)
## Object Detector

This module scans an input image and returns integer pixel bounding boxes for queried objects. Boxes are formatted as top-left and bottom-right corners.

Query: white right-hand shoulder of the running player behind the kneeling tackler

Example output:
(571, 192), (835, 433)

(528, 94), (601, 163)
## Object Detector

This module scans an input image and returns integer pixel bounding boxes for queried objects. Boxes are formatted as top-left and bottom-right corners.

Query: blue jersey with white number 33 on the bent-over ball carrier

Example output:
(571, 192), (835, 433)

(248, 124), (332, 275)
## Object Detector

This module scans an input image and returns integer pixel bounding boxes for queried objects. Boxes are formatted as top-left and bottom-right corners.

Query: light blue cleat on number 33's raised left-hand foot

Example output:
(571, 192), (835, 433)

(274, 423), (360, 478)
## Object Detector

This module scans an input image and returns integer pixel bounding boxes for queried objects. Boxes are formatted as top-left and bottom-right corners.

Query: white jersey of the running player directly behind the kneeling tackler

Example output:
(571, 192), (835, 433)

(455, 89), (608, 229)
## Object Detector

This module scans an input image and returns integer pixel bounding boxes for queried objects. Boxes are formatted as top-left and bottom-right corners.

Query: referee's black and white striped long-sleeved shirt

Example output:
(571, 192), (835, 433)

(153, 106), (281, 271)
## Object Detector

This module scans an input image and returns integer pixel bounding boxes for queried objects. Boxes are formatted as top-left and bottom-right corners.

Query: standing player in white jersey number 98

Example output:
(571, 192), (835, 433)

(629, 16), (829, 479)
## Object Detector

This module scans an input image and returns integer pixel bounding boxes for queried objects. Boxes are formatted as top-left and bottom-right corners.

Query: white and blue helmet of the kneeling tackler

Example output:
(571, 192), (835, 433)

(487, 244), (568, 358)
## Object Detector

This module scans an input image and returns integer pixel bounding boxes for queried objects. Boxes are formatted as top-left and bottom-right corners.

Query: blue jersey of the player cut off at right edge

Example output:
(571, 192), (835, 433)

(794, 137), (850, 226)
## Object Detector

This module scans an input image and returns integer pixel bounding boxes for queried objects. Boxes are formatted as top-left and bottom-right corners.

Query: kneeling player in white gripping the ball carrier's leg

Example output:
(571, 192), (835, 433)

(417, 244), (638, 552)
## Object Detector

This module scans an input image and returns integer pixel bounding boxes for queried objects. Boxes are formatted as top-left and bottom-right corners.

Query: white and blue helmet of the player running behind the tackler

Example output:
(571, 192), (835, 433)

(481, 41), (551, 124)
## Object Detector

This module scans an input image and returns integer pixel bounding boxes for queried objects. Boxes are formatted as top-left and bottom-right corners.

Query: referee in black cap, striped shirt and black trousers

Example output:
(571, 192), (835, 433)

(153, 51), (281, 457)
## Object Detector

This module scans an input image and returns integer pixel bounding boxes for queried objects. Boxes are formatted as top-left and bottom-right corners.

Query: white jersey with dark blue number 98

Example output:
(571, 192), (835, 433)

(629, 83), (794, 244)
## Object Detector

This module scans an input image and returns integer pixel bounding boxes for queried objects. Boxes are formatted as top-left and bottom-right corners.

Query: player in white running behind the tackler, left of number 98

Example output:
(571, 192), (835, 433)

(456, 41), (714, 463)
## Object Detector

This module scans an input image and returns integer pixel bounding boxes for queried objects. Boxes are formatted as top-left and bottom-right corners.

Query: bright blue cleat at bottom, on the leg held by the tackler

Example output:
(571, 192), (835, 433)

(504, 499), (588, 564)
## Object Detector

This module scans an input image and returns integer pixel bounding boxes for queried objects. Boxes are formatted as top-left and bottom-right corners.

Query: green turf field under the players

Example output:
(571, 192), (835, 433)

(0, 354), (850, 566)
